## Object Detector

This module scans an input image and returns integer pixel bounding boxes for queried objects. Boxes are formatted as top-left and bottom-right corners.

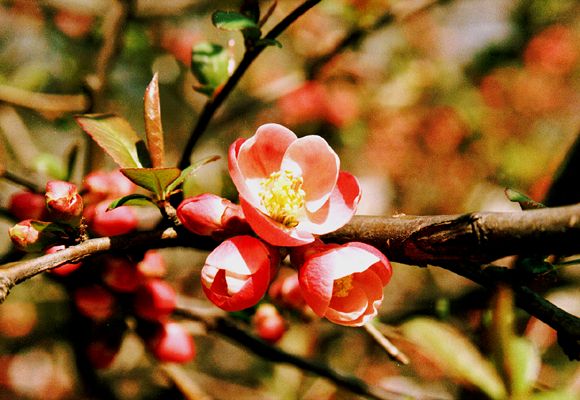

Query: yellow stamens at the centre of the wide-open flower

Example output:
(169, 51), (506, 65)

(258, 170), (305, 228)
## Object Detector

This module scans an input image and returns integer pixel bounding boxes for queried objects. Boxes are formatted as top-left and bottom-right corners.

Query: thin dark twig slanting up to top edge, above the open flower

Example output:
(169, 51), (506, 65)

(178, 0), (321, 169)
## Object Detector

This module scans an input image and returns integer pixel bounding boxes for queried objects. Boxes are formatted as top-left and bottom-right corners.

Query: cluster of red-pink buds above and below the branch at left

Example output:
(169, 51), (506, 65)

(9, 171), (196, 368)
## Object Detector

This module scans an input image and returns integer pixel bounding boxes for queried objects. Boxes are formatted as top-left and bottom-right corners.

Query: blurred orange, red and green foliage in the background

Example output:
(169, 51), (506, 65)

(0, 0), (580, 400)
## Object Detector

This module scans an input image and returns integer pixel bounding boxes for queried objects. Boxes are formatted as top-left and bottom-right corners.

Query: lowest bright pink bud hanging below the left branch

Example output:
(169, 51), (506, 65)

(147, 322), (195, 364)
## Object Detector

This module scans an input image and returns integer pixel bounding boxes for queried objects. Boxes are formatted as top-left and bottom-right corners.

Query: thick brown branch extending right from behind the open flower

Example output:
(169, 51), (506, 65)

(322, 204), (580, 265)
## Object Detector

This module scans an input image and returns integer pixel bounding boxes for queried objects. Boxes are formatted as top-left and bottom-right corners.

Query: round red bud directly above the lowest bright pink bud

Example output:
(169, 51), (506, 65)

(134, 279), (177, 321)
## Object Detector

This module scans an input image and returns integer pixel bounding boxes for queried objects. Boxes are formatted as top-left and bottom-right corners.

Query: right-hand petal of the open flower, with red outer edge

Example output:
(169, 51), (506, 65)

(298, 172), (361, 235)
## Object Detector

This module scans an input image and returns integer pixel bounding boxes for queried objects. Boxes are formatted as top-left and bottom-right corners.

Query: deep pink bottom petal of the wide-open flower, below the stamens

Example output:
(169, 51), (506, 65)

(240, 196), (314, 247)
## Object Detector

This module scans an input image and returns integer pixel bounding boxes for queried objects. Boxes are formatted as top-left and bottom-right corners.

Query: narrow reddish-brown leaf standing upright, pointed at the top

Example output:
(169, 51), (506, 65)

(143, 73), (165, 168)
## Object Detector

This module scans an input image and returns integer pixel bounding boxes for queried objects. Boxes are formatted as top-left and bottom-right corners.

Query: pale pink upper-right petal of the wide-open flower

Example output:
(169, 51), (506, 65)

(280, 135), (340, 212)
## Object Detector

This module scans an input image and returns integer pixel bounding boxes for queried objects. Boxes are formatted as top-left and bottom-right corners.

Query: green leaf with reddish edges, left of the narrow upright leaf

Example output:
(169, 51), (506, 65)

(75, 114), (142, 168)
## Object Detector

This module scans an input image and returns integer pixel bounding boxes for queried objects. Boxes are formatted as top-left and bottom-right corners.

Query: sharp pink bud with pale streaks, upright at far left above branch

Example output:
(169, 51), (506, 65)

(45, 181), (83, 224)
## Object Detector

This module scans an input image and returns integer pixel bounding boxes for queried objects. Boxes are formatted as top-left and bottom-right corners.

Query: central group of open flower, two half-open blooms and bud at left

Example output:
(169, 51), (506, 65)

(177, 124), (392, 326)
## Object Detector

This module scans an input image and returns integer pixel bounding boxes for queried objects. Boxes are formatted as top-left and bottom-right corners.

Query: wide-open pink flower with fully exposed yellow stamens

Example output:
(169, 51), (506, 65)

(229, 124), (361, 246)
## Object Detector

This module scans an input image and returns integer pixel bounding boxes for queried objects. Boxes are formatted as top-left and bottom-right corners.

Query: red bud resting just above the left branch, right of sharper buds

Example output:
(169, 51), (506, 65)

(85, 201), (139, 236)
